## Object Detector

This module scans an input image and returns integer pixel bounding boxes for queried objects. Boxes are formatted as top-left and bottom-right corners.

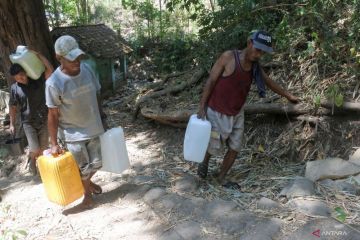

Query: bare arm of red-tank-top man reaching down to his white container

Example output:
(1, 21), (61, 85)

(198, 51), (233, 119)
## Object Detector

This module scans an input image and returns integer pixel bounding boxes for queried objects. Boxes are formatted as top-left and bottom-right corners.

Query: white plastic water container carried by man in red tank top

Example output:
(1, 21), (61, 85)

(184, 114), (211, 162)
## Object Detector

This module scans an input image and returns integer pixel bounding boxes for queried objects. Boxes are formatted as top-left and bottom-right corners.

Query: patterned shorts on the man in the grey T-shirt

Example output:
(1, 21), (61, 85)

(66, 137), (102, 179)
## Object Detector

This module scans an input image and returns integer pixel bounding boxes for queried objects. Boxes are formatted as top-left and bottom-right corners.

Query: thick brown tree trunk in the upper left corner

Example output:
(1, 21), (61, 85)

(0, 0), (54, 85)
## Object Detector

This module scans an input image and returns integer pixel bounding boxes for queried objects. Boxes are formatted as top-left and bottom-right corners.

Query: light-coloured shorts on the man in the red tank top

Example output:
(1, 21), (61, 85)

(206, 107), (245, 155)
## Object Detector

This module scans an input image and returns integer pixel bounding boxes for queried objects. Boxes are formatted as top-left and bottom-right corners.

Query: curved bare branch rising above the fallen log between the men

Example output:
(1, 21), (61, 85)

(134, 68), (205, 120)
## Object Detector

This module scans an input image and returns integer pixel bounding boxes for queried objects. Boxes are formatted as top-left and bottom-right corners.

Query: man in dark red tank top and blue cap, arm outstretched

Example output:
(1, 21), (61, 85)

(198, 31), (299, 188)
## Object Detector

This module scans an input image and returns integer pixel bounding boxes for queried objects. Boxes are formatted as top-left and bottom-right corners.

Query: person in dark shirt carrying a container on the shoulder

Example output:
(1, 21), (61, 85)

(9, 52), (53, 175)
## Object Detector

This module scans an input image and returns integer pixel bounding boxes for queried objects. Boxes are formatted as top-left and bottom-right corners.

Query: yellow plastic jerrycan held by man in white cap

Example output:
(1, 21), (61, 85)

(37, 152), (84, 206)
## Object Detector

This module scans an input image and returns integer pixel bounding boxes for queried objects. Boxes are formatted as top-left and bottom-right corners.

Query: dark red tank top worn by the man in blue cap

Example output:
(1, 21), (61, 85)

(208, 50), (252, 116)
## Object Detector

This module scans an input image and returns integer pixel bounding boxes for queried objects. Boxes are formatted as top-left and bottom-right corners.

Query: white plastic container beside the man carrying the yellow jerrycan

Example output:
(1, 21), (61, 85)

(100, 127), (130, 173)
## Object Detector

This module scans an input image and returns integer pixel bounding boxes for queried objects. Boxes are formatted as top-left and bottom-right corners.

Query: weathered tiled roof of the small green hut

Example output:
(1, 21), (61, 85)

(51, 24), (132, 58)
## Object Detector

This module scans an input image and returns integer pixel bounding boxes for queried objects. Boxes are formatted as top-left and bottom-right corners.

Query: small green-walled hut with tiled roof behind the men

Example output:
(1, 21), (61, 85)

(51, 24), (132, 96)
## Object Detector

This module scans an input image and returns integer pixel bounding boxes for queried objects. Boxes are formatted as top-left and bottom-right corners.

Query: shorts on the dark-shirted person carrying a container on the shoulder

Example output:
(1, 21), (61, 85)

(23, 122), (49, 153)
